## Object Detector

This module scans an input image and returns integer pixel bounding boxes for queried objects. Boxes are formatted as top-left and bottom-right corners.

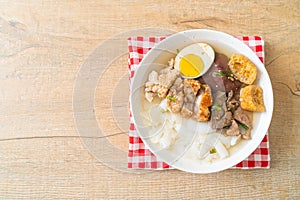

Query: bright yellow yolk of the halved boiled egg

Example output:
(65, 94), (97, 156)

(179, 54), (203, 77)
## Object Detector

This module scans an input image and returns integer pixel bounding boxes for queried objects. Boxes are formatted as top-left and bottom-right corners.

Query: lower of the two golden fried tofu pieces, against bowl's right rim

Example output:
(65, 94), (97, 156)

(240, 85), (265, 112)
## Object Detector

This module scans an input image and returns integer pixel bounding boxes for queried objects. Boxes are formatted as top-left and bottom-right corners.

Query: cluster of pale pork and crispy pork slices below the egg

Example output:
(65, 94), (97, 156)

(145, 67), (212, 121)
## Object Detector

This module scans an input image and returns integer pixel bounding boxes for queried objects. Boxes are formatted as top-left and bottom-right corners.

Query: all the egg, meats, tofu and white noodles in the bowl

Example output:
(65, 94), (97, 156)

(144, 43), (265, 162)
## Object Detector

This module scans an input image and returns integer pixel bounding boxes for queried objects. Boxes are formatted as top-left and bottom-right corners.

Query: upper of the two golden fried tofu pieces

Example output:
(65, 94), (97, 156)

(229, 54), (257, 85)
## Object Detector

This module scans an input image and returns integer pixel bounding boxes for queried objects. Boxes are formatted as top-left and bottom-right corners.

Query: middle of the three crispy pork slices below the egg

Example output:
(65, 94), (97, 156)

(181, 79), (201, 118)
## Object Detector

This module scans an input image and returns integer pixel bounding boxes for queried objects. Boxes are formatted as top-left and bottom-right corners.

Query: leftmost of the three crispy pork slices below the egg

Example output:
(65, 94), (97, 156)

(166, 77), (184, 113)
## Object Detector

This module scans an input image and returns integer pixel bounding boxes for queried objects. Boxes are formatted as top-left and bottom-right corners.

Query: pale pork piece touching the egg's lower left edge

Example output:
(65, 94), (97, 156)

(157, 67), (180, 98)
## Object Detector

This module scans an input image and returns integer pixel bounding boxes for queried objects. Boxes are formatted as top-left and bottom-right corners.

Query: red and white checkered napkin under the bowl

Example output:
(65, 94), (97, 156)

(128, 36), (270, 169)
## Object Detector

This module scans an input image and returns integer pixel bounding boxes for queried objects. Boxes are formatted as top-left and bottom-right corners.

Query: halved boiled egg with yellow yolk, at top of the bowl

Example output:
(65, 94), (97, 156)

(174, 43), (215, 78)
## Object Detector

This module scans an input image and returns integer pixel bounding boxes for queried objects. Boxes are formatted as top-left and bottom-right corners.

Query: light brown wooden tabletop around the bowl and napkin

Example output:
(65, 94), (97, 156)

(0, 0), (300, 199)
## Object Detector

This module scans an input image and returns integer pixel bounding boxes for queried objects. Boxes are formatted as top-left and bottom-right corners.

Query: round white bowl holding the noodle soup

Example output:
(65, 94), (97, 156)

(130, 29), (273, 173)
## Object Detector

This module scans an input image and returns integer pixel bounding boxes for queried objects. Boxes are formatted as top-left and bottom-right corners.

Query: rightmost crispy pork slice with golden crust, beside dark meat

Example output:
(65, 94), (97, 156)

(193, 85), (212, 122)
